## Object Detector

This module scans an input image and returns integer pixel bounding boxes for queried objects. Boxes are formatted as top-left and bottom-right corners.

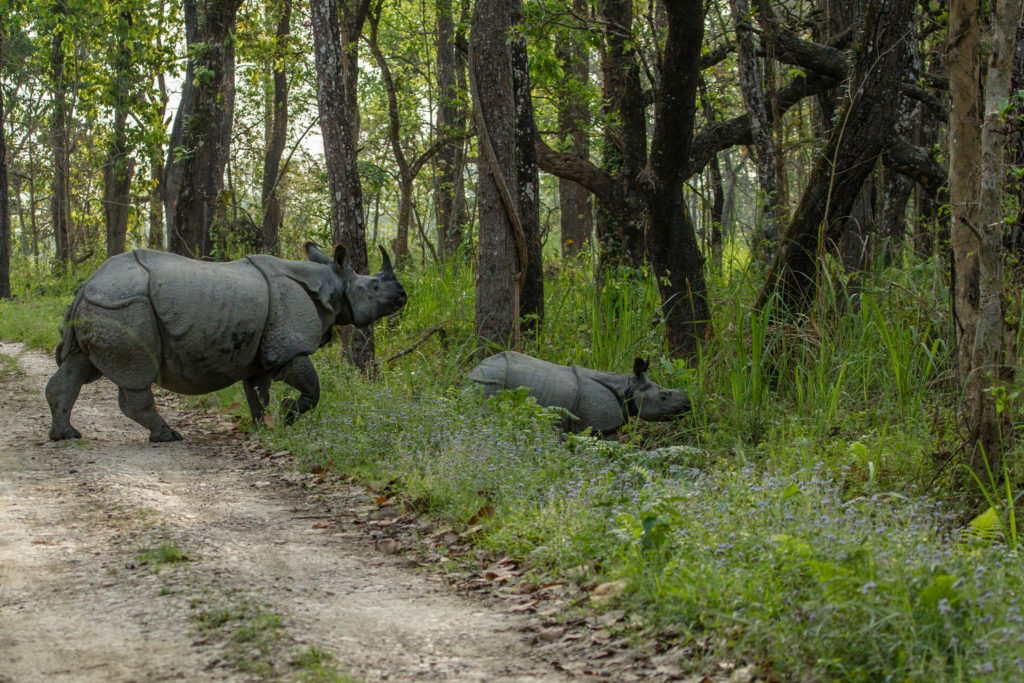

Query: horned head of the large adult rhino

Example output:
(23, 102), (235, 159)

(303, 242), (409, 327)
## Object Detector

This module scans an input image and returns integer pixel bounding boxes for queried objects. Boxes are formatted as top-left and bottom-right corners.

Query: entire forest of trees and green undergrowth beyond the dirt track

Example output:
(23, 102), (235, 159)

(0, 0), (1024, 680)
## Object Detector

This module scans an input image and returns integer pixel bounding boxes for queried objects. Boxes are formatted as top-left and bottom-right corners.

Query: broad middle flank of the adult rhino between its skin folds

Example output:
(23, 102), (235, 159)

(137, 250), (269, 393)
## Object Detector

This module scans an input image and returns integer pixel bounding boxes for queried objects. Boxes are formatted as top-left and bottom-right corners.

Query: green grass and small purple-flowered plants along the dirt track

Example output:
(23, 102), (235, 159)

(0, 242), (1024, 680)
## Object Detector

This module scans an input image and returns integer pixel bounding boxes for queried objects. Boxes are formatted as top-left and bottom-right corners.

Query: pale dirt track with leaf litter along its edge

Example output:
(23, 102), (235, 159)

(0, 343), (699, 682)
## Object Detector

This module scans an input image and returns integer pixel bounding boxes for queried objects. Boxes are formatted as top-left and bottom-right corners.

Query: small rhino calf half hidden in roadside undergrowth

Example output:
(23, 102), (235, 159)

(469, 351), (690, 436)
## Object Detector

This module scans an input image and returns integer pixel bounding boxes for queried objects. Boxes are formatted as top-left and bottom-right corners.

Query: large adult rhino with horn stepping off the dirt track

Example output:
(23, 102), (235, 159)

(46, 242), (407, 441)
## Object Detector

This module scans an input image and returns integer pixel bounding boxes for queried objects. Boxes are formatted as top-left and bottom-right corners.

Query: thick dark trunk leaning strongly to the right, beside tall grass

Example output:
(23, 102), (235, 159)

(757, 0), (916, 314)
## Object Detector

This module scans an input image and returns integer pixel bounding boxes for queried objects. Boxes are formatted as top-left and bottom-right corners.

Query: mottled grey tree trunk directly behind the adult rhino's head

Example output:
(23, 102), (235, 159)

(310, 0), (374, 372)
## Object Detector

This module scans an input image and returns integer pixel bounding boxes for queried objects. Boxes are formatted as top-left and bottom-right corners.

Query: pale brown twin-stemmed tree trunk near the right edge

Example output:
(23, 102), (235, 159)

(946, 0), (1018, 485)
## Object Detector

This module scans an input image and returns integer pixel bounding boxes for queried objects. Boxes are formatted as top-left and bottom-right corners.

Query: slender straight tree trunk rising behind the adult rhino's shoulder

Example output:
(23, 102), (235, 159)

(260, 0), (292, 254)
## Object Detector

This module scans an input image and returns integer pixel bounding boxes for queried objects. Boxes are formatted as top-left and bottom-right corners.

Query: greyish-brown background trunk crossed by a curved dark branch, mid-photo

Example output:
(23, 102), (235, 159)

(555, 0), (594, 258)
